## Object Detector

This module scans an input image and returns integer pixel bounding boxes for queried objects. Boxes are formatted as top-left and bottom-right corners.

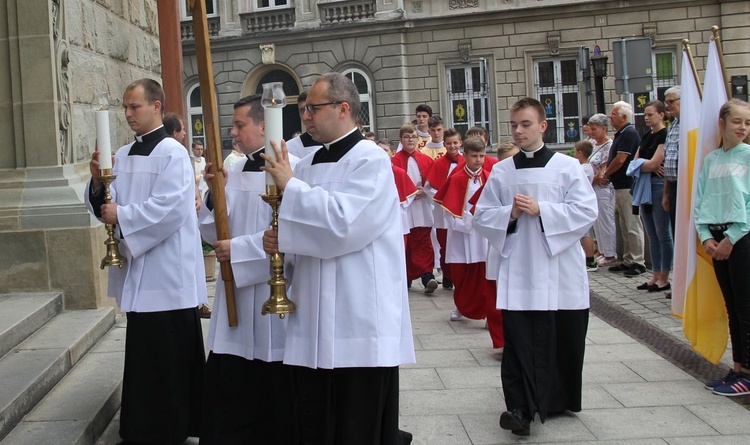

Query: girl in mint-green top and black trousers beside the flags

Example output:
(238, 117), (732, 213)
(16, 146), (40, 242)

(695, 99), (750, 397)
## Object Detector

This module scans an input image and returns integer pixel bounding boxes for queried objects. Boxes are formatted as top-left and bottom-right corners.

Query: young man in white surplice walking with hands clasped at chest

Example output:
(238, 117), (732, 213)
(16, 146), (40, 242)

(474, 98), (597, 436)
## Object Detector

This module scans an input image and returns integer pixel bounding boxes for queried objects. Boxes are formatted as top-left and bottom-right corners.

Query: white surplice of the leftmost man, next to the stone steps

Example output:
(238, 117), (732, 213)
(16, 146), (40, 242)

(85, 138), (206, 312)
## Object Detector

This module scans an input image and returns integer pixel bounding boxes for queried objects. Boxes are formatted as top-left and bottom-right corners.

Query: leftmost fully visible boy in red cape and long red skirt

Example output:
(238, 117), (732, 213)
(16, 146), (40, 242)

(391, 124), (437, 294)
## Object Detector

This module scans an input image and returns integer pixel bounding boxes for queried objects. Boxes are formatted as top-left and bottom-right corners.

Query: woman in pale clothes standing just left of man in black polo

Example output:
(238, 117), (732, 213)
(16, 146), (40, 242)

(586, 113), (617, 266)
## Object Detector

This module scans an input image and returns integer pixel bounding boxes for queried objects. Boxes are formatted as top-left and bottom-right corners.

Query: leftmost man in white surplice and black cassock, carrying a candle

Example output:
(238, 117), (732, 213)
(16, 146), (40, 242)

(85, 79), (206, 443)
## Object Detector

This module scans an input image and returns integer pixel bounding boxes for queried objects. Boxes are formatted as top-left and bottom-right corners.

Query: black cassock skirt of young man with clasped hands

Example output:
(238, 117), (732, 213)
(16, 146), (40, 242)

(500, 309), (589, 422)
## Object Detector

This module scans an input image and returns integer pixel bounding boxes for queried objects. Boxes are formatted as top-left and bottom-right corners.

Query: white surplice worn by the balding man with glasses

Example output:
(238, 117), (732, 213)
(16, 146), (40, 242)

(278, 140), (415, 369)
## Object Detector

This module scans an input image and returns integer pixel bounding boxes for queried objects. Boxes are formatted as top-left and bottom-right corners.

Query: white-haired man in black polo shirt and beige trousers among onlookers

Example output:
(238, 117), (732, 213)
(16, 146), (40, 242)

(604, 101), (646, 276)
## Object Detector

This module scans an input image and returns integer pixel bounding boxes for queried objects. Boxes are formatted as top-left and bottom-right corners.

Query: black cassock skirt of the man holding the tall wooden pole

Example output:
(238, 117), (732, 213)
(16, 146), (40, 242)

(200, 352), (298, 445)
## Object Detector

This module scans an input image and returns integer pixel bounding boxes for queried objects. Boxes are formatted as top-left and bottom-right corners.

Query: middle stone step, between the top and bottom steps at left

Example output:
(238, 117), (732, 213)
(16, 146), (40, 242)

(0, 308), (116, 444)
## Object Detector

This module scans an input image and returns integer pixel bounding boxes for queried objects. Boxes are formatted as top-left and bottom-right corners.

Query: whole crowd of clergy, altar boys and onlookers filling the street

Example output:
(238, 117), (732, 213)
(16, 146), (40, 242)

(86, 73), (750, 445)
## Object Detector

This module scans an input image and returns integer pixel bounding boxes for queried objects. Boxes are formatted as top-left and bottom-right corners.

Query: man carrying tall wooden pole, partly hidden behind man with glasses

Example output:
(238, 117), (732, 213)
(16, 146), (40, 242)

(200, 94), (297, 445)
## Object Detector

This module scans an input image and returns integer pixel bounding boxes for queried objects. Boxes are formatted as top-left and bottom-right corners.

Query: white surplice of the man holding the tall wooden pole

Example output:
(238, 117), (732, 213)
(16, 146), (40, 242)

(200, 154), (297, 362)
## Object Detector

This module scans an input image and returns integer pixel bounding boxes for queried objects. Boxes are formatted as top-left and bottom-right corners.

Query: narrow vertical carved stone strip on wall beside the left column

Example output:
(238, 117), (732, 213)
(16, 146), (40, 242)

(52, 0), (76, 164)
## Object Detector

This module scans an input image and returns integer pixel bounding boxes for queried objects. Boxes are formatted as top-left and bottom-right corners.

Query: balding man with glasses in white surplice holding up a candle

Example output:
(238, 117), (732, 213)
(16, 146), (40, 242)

(264, 73), (415, 444)
